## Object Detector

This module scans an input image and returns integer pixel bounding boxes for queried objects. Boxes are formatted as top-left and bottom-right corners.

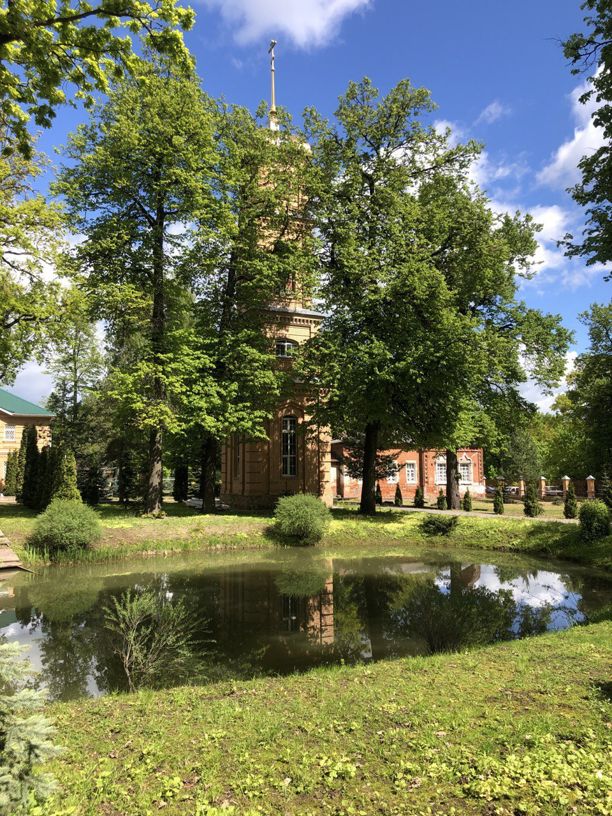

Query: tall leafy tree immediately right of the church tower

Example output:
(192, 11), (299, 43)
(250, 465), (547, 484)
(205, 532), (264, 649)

(306, 79), (479, 513)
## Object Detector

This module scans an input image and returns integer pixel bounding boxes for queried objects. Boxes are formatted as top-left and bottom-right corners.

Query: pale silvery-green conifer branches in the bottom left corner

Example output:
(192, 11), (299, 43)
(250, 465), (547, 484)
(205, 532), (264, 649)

(0, 643), (58, 816)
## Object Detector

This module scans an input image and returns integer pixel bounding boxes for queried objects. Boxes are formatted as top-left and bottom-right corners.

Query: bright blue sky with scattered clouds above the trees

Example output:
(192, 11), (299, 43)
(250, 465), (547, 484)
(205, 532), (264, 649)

(15, 0), (610, 405)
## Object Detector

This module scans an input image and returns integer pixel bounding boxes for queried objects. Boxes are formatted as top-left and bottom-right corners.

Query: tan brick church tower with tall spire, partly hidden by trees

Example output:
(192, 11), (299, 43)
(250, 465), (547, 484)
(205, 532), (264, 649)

(221, 40), (334, 510)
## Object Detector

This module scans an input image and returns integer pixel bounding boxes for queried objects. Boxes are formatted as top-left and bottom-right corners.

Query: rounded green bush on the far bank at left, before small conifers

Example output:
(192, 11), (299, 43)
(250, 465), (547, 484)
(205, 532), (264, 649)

(28, 499), (102, 558)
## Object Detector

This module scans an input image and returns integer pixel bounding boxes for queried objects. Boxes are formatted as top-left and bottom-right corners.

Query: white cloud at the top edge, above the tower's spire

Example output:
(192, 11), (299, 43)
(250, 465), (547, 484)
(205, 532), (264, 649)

(204, 0), (371, 49)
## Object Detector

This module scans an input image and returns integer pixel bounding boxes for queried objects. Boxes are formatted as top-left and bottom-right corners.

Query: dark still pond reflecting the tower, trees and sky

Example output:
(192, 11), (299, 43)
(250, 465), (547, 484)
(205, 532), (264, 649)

(0, 548), (612, 699)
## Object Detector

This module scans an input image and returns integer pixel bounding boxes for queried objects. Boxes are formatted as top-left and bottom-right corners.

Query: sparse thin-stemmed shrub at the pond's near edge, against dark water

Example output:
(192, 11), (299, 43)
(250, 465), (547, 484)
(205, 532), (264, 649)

(104, 589), (202, 691)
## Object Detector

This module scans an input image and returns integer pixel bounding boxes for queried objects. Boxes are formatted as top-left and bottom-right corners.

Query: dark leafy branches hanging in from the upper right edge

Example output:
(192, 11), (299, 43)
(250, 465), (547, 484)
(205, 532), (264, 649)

(563, 0), (612, 279)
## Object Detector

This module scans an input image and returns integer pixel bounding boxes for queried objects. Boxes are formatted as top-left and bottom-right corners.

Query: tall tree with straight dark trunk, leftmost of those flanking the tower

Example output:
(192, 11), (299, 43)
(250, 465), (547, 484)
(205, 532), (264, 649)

(57, 64), (218, 514)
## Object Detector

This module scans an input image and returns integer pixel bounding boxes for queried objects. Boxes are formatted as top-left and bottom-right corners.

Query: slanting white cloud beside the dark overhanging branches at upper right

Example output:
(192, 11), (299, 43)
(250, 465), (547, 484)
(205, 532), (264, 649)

(537, 76), (604, 188)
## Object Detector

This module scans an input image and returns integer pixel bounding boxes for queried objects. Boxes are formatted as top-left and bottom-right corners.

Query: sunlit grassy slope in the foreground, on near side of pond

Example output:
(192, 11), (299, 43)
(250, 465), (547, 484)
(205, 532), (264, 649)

(45, 623), (612, 816)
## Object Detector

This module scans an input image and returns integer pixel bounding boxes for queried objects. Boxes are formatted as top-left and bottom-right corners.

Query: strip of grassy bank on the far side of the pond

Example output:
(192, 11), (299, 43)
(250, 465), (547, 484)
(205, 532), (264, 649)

(0, 504), (612, 570)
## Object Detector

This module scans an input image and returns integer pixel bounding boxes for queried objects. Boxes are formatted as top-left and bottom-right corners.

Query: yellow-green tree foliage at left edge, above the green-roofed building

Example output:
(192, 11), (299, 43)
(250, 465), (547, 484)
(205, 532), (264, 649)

(0, 139), (62, 384)
